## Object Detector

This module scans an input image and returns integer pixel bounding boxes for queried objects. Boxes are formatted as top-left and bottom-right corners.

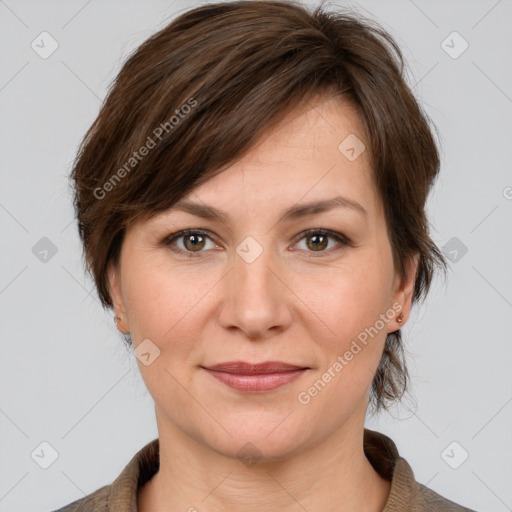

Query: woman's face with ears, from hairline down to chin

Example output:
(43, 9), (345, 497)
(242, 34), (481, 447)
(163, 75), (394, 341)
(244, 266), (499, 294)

(109, 98), (416, 460)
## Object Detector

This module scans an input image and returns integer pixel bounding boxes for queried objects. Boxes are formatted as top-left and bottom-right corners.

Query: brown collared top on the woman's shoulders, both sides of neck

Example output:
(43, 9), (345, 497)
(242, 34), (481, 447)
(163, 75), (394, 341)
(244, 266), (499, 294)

(54, 428), (475, 512)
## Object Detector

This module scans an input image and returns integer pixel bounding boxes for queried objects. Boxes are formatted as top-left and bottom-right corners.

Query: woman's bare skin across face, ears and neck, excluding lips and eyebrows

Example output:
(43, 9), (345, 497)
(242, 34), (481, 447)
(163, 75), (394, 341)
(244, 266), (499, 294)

(108, 97), (418, 512)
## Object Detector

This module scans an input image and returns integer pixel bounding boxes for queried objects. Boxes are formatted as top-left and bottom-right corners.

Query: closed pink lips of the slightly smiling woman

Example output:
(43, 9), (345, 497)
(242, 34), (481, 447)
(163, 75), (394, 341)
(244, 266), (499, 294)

(202, 361), (309, 392)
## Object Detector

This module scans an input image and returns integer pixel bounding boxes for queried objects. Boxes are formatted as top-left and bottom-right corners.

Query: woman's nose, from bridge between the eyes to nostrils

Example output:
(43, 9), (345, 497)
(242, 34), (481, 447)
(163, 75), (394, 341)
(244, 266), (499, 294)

(219, 241), (293, 340)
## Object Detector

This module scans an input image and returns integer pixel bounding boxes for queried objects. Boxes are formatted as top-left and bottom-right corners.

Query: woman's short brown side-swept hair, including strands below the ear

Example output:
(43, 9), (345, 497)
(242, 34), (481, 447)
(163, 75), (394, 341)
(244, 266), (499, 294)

(71, 0), (446, 410)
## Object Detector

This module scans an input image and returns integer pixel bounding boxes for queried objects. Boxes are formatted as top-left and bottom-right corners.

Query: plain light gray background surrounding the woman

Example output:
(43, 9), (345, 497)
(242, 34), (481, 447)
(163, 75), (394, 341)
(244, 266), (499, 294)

(0, 0), (512, 512)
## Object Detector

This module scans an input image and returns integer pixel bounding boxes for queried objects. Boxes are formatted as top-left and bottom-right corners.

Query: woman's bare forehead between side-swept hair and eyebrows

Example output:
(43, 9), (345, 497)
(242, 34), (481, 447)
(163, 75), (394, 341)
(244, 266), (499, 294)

(171, 97), (380, 222)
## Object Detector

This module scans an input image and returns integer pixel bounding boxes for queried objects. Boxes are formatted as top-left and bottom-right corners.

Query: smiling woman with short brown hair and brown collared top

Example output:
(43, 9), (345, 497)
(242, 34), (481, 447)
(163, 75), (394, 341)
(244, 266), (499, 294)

(51, 0), (476, 512)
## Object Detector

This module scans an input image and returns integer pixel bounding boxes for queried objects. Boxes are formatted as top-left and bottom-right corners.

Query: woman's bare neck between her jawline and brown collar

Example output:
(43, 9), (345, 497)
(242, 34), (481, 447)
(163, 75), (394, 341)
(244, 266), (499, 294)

(138, 414), (391, 512)
